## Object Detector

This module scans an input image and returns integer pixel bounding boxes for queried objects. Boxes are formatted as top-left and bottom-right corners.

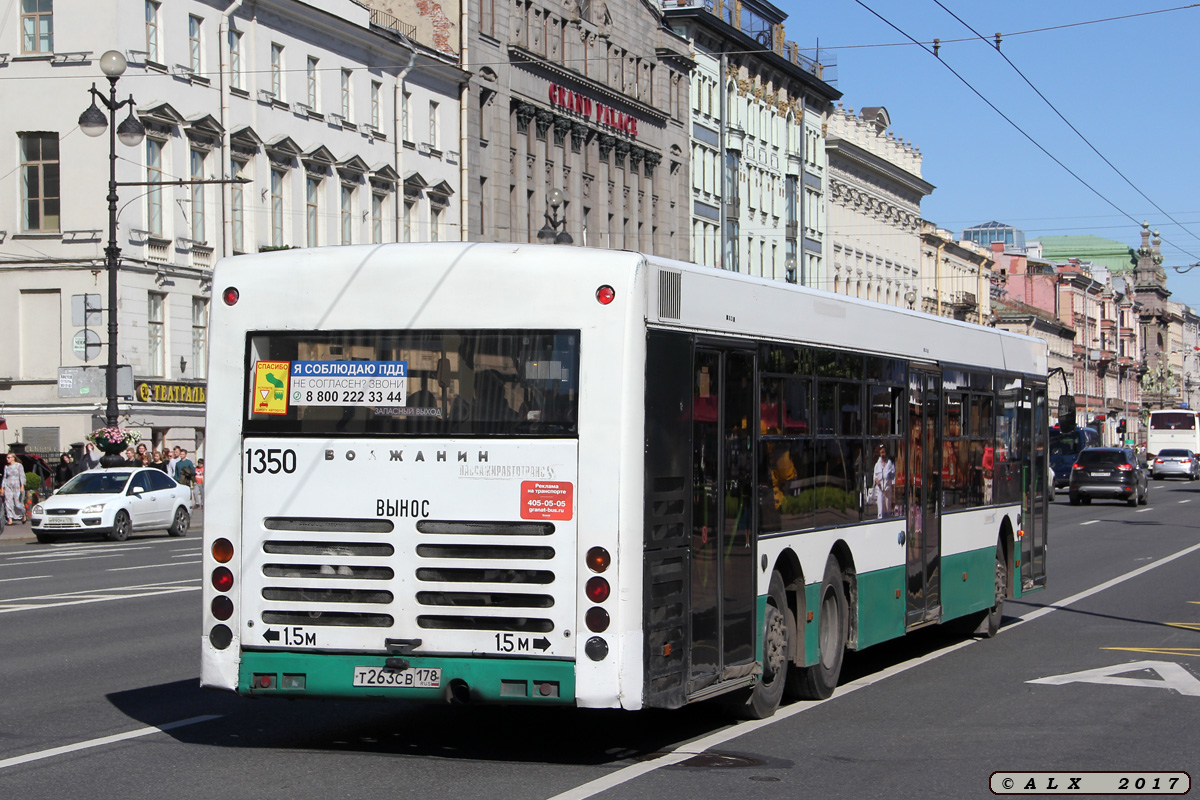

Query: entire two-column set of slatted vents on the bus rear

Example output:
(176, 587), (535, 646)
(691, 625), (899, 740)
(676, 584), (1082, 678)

(254, 517), (557, 633)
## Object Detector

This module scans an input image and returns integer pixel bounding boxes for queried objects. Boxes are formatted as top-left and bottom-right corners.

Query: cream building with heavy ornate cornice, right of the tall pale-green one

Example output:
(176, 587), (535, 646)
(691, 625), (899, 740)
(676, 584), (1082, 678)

(830, 107), (934, 307)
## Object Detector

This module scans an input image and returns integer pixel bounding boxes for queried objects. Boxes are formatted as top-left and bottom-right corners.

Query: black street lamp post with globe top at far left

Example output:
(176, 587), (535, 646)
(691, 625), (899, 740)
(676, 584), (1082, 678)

(79, 50), (146, 427)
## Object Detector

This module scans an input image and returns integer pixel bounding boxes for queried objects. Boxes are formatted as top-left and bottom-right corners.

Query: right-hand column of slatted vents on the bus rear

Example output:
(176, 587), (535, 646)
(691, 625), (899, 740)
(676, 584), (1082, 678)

(416, 519), (554, 633)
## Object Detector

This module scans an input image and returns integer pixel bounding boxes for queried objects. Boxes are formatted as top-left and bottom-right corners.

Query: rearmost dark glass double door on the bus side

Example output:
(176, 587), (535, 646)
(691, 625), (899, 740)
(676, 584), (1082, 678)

(688, 348), (757, 693)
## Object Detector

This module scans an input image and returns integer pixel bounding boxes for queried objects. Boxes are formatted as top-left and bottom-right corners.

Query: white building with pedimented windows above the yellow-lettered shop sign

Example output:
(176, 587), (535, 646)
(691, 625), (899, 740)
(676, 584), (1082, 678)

(0, 0), (464, 455)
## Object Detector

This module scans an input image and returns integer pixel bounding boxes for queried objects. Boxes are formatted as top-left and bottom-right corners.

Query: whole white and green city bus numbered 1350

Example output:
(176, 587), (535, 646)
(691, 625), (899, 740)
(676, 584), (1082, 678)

(202, 243), (1048, 717)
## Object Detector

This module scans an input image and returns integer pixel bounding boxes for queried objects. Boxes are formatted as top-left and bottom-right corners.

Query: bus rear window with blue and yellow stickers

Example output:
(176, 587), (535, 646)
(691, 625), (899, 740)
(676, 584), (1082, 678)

(244, 330), (580, 437)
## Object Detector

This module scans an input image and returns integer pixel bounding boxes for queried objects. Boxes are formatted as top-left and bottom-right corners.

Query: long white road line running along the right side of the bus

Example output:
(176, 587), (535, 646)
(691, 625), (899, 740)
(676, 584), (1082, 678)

(548, 545), (1200, 800)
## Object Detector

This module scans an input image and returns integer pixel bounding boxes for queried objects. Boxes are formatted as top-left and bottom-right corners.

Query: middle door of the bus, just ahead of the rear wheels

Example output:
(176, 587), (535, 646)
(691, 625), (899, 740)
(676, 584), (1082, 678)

(905, 368), (942, 627)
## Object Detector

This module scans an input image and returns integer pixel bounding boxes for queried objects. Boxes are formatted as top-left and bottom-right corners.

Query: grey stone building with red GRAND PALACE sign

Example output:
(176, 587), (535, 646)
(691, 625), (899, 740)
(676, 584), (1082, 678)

(462, 0), (691, 259)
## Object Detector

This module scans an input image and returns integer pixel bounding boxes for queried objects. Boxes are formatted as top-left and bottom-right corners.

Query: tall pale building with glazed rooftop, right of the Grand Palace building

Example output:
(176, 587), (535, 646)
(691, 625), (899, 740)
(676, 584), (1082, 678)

(665, 0), (841, 283)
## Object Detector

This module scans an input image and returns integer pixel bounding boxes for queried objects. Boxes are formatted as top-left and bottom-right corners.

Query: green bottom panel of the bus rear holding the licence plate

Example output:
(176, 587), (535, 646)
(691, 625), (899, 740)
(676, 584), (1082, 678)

(238, 650), (575, 704)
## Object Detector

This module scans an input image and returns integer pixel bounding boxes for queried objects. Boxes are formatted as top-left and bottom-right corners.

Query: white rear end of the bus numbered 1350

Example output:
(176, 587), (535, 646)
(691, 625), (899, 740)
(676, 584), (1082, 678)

(202, 243), (643, 706)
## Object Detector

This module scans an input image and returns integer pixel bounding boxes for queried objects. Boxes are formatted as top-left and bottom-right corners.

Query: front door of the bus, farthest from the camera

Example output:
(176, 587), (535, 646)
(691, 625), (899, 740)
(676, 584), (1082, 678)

(1016, 383), (1054, 591)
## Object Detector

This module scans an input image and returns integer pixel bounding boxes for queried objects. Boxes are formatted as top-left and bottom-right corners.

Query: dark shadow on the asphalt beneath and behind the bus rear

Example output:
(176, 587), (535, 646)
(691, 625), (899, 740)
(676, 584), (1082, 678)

(108, 680), (733, 765)
